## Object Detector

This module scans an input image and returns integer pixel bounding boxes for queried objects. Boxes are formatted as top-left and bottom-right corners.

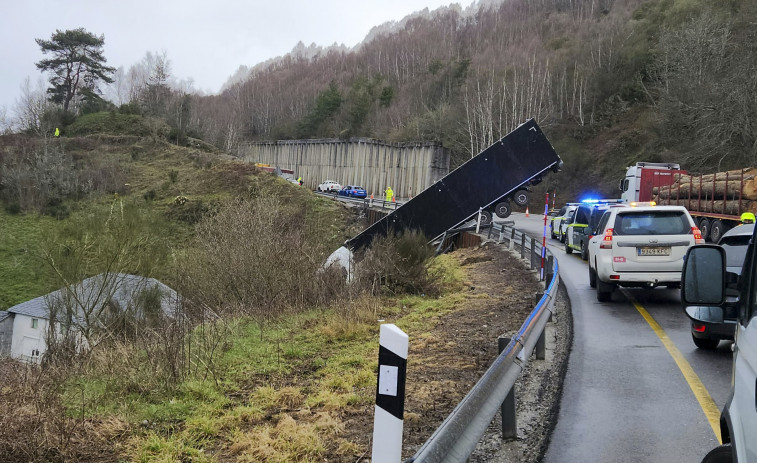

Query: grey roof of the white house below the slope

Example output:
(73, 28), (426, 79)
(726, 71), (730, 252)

(8, 273), (177, 321)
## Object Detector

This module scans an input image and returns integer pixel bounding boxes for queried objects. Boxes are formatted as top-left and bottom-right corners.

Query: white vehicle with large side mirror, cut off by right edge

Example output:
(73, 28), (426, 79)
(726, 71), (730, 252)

(681, 232), (757, 463)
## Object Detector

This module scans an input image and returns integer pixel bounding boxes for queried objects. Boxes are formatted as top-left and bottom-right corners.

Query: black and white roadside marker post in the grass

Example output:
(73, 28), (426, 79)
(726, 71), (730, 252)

(372, 324), (408, 463)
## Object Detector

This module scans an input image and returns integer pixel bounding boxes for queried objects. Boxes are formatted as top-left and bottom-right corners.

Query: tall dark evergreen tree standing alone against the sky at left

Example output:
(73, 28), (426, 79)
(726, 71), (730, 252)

(35, 28), (115, 112)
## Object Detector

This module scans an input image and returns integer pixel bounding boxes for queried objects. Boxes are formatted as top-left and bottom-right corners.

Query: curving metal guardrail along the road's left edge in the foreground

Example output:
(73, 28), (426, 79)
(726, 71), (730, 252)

(405, 223), (560, 463)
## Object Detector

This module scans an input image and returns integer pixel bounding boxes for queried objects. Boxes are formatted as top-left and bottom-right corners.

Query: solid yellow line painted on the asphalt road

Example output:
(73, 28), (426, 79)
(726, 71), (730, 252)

(621, 289), (723, 444)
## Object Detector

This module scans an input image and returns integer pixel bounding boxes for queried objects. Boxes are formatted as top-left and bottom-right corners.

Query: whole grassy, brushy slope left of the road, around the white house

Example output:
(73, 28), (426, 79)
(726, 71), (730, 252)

(0, 113), (556, 462)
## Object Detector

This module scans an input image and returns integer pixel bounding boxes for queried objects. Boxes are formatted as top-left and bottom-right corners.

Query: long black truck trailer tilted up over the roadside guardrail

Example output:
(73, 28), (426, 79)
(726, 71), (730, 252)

(345, 119), (561, 250)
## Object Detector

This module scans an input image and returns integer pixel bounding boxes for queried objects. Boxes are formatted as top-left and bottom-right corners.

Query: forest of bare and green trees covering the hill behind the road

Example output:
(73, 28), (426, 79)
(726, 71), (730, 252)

(7, 0), (757, 199)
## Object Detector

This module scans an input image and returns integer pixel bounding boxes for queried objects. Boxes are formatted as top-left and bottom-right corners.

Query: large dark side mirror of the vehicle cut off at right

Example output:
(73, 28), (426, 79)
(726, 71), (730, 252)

(681, 244), (726, 308)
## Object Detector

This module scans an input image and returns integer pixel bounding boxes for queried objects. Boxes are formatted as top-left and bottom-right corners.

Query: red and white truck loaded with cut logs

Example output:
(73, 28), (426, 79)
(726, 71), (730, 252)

(620, 162), (757, 243)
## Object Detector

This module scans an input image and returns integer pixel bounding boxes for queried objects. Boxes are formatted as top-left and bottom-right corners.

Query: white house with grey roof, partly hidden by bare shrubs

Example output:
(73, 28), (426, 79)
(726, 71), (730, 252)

(0, 273), (178, 363)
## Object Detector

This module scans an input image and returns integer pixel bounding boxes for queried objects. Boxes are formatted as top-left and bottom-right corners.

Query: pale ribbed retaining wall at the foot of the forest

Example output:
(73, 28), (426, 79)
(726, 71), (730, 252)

(238, 138), (449, 199)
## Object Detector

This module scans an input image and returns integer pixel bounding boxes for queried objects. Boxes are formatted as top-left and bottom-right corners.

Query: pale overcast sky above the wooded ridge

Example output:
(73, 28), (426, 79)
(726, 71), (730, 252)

(0, 0), (473, 116)
